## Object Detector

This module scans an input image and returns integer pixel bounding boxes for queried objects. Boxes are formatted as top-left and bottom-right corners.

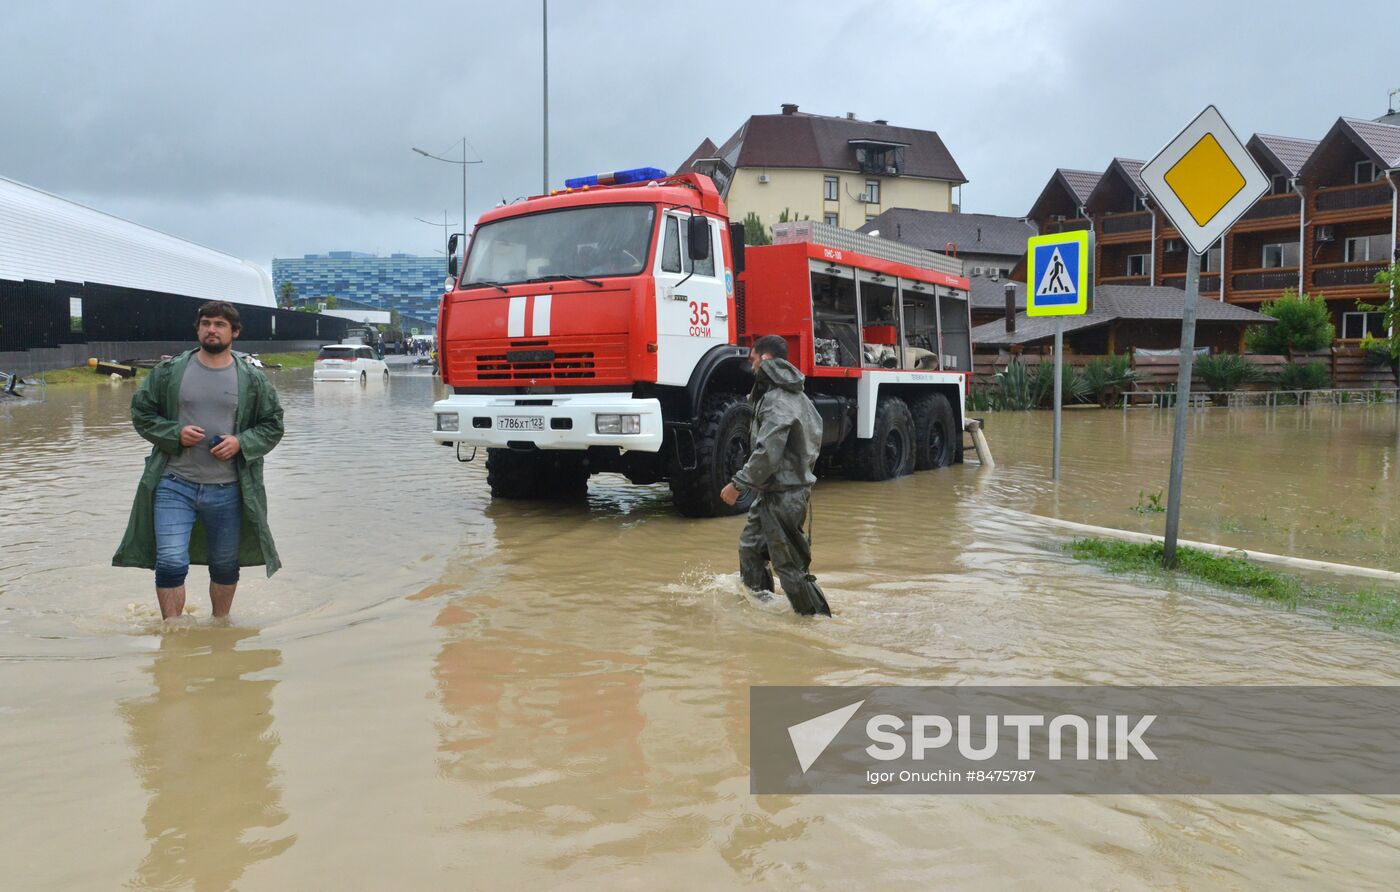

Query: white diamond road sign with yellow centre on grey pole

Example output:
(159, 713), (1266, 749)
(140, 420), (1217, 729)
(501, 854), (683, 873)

(1142, 105), (1268, 253)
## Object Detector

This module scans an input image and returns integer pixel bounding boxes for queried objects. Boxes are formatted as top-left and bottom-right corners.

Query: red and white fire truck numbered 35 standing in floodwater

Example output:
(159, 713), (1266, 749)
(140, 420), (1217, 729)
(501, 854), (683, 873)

(433, 168), (972, 517)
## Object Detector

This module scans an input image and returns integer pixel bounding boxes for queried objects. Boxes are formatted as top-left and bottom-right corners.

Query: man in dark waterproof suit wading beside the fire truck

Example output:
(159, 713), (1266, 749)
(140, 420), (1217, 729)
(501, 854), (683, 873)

(720, 335), (832, 616)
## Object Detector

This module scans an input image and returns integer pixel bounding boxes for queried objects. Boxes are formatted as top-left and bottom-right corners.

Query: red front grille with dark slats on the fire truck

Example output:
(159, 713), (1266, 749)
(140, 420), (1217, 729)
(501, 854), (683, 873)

(448, 335), (627, 385)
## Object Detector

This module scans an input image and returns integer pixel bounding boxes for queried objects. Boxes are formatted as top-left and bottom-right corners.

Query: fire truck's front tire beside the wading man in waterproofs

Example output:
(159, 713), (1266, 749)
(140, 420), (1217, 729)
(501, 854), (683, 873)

(671, 393), (753, 517)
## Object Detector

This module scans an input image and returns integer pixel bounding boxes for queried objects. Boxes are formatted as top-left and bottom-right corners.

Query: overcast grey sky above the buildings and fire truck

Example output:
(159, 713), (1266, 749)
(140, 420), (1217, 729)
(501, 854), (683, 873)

(0, 0), (1400, 266)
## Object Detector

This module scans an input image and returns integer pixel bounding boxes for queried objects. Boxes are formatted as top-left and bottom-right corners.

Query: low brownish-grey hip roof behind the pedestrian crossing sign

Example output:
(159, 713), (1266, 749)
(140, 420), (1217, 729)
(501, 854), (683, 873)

(972, 284), (1273, 347)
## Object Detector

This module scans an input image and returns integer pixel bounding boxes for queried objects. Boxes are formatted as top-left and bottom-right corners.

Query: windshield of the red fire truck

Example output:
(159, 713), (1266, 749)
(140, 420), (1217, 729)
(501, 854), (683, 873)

(462, 204), (657, 287)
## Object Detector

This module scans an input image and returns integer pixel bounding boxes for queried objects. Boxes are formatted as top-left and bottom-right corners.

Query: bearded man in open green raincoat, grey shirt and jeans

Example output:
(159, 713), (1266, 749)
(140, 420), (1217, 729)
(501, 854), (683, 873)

(112, 301), (283, 619)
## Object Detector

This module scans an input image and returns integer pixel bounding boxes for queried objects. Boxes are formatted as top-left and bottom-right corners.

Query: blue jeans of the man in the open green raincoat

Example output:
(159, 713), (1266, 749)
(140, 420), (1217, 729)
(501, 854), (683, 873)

(155, 473), (244, 588)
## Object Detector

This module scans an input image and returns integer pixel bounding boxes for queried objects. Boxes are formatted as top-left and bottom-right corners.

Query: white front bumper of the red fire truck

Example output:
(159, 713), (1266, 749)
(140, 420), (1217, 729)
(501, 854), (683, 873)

(433, 393), (664, 452)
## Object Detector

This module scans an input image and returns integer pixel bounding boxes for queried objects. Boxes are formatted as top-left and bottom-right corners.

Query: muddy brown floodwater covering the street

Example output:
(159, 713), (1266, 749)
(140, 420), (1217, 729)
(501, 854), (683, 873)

(0, 371), (1400, 889)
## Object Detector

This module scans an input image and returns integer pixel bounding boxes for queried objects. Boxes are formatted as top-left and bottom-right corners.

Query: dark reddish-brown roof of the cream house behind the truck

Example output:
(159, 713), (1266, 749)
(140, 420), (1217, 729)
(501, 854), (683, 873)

(718, 111), (967, 183)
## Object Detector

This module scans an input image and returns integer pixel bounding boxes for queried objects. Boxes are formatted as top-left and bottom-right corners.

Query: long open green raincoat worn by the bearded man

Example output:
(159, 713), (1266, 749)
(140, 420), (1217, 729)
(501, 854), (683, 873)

(112, 344), (283, 576)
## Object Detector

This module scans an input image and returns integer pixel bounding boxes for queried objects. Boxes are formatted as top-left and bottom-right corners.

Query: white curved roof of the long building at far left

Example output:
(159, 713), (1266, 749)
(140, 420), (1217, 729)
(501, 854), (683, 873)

(0, 176), (277, 307)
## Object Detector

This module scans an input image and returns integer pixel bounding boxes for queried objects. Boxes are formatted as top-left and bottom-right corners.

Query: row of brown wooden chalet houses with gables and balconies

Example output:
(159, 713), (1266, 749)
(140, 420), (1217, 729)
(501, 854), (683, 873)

(1012, 118), (1400, 342)
